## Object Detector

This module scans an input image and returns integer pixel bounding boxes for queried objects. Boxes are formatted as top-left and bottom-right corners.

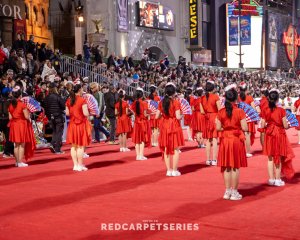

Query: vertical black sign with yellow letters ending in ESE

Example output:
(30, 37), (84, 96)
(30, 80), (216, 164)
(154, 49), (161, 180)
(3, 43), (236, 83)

(189, 0), (199, 46)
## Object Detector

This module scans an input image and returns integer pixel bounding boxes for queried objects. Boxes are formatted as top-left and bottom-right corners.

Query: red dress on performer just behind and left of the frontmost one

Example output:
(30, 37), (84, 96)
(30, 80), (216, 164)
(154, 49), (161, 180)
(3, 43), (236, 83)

(201, 93), (220, 139)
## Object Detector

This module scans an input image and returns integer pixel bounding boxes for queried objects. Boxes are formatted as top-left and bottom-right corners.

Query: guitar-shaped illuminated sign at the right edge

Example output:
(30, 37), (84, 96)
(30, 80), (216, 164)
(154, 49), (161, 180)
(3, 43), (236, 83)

(282, 25), (300, 62)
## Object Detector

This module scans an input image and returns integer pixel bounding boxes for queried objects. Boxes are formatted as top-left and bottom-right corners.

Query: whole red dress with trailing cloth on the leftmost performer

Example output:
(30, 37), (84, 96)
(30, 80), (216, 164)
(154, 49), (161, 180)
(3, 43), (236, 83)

(8, 100), (36, 160)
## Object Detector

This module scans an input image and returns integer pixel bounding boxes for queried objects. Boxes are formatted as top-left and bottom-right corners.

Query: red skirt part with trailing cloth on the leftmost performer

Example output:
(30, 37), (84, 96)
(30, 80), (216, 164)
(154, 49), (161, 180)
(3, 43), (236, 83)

(8, 119), (36, 160)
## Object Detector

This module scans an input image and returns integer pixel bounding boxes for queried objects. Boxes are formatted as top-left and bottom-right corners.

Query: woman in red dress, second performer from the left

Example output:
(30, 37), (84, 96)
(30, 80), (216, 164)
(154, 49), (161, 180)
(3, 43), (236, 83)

(66, 84), (92, 172)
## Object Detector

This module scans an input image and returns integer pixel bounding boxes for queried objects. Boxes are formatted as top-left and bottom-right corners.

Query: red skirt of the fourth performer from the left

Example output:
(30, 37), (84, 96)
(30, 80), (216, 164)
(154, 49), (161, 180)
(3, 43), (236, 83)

(132, 119), (151, 146)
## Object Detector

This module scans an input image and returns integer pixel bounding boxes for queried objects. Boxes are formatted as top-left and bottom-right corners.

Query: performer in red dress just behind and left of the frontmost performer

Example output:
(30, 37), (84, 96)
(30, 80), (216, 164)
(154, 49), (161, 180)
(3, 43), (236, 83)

(201, 81), (221, 166)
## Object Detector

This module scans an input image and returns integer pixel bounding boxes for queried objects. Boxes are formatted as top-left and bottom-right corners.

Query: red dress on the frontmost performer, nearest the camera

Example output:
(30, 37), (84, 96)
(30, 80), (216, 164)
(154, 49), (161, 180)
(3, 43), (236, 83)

(217, 104), (247, 171)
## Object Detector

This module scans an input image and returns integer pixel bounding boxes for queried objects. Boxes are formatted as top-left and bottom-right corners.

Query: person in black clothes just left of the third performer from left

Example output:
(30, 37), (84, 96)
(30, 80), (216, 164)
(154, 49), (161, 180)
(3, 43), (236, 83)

(104, 85), (117, 144)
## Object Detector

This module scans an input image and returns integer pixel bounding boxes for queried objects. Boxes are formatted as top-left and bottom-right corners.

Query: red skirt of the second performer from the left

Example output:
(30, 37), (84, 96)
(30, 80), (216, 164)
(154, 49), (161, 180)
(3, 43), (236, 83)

(67, 120), (92, 147)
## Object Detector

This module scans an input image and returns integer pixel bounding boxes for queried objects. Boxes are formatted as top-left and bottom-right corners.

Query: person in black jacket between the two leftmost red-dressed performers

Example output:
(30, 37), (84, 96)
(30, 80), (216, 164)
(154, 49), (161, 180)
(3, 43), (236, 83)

(44, 83), (66, 154)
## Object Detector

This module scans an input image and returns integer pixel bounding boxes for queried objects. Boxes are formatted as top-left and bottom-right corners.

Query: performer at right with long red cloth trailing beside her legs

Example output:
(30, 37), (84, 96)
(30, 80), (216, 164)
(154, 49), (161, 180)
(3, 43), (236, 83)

(262, 89), (295, 187)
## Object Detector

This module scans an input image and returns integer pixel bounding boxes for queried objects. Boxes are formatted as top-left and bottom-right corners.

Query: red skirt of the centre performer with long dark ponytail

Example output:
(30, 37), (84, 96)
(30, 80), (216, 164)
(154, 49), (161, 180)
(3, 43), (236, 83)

(158, 118), (184, 155)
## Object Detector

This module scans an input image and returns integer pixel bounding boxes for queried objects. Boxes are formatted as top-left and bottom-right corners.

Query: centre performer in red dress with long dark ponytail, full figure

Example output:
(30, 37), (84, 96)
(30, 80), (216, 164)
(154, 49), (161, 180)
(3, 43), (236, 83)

(156, 83), (184, 177)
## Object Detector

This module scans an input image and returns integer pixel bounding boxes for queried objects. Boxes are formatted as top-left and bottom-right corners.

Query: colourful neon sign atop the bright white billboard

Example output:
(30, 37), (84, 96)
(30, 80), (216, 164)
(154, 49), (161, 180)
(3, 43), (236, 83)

(228, 0), (263, 16)
